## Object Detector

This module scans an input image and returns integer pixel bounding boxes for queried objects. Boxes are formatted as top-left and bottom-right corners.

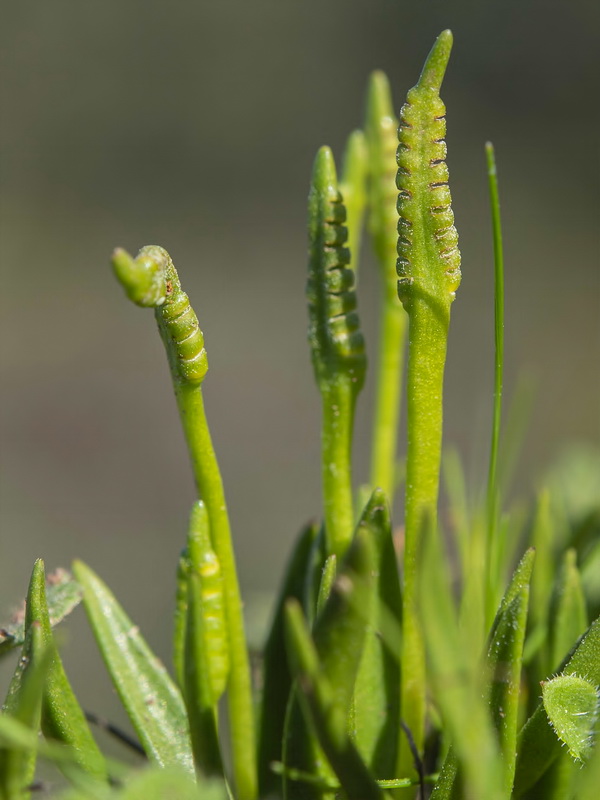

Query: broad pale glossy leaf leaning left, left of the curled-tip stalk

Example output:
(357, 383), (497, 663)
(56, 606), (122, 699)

(73, 561), (194, 772)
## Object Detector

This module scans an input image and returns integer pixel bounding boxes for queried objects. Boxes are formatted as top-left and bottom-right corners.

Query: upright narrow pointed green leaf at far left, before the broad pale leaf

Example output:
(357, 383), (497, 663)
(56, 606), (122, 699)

(25, 559), (106, 778)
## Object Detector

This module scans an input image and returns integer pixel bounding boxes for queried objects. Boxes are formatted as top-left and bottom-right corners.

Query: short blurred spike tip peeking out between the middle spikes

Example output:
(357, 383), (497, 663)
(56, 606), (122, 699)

(340, 130), (369, 278)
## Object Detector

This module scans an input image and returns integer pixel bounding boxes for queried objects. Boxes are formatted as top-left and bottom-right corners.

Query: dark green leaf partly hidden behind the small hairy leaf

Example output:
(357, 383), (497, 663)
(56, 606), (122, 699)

(513, 618), (600, 800)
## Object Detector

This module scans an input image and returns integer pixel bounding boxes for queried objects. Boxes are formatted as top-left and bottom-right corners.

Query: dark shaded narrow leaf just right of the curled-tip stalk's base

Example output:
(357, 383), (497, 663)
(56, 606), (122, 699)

(258, 523), (319, 797)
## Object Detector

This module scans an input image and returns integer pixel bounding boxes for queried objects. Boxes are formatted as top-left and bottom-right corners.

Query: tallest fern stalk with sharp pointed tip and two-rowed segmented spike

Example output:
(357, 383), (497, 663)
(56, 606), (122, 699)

(397, 31), (460, 775)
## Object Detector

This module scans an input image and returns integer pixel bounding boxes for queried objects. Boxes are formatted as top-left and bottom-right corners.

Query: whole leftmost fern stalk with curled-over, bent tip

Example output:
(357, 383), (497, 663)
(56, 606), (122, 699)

(113, 246), (257, 800)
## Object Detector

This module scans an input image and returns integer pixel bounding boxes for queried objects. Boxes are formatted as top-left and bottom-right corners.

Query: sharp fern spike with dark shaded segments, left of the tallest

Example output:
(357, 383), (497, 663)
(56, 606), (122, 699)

(306, 147), (366, 557)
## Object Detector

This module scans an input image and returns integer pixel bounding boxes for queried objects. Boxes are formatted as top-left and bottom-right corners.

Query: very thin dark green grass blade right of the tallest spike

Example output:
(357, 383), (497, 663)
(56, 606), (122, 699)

(485, 142), (504, 623)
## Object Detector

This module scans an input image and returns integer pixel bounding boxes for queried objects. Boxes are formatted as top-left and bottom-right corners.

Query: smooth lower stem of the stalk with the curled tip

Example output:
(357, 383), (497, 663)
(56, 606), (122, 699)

(175, 382), (257, 800)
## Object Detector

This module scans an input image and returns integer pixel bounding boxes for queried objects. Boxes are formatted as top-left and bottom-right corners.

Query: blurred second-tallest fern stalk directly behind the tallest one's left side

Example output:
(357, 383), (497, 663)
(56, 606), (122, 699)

(366, 72), (407, 505)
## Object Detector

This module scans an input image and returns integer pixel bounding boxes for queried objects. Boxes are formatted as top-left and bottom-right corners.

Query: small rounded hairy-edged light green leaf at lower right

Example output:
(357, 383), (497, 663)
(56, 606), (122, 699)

(542, 675), (599, 761)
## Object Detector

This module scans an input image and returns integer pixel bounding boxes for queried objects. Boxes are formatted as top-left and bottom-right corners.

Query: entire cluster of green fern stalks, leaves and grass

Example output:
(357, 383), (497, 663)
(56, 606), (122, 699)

(0, 31), (600, 800)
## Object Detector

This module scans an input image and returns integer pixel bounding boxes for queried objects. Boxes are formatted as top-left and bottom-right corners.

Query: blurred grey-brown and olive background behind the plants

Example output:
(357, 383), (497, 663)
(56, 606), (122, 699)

(0, 0), (600, 752)
